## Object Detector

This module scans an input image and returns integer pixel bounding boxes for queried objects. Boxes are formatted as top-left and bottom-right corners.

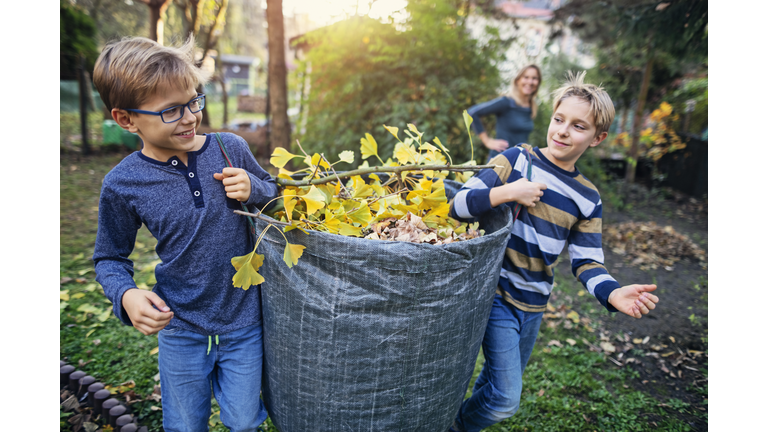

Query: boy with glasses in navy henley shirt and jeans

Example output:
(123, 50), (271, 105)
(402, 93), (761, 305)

(93, 37), (277, 432)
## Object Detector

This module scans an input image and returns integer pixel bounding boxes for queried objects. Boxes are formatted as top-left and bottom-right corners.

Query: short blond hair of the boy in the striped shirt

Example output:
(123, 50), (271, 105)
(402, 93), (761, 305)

(552, 71), (616, 136)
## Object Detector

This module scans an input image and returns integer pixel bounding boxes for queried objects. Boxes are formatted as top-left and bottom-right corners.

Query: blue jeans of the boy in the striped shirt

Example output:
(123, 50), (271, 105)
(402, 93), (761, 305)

(454, 295), (543, 432)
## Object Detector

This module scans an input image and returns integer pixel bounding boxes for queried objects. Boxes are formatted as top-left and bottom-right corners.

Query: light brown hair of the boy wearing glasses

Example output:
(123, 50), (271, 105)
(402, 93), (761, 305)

(93, 35), (210, 110)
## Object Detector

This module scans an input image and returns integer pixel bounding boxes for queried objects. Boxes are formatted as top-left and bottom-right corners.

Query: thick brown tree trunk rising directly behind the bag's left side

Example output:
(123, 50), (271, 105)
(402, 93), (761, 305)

(267, 0), (291, 154)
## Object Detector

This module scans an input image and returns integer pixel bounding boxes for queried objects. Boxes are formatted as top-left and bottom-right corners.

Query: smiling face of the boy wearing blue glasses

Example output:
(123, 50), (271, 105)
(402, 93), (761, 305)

(118, 86), (205, 164)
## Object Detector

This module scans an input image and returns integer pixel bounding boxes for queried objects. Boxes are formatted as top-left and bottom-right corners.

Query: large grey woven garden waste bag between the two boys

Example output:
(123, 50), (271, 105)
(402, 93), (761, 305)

(256, 181), (513, 432)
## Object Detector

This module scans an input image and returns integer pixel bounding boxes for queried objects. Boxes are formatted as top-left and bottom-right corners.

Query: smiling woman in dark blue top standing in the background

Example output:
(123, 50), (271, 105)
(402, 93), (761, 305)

(467, 64), (541, 160)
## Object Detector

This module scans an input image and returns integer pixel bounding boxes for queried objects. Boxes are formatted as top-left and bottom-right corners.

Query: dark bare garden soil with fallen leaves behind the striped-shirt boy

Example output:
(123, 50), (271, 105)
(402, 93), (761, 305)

(555, 186), (708, 431)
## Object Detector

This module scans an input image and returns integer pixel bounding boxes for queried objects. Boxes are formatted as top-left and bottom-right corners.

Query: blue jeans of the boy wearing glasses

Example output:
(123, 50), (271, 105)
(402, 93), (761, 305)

(158, 323), (267, 432)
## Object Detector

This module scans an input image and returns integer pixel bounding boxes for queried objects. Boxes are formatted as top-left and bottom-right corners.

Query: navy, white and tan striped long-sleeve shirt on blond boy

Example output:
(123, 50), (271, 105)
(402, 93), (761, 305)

(450, 144), (620, 312)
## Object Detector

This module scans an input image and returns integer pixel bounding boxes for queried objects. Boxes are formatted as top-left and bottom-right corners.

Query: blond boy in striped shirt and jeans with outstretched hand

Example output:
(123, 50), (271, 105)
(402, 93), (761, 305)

(451, 72), (659, 432)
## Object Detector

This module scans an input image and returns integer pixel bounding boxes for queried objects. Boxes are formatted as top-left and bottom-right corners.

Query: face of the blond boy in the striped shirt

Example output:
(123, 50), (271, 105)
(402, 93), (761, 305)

(542, 96), (608, 171)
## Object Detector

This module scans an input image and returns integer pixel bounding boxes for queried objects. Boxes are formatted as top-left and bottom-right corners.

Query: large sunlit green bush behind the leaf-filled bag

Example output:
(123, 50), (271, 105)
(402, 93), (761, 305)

(294, 0), (505, 169)
